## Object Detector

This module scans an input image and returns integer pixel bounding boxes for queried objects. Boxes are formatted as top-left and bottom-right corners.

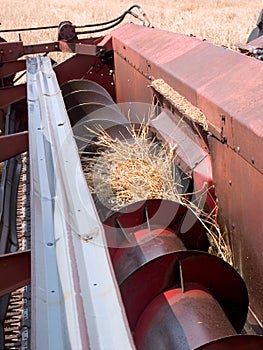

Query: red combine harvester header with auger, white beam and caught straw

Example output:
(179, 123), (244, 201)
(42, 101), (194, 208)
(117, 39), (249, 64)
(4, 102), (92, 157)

(0, 5), (263, 350)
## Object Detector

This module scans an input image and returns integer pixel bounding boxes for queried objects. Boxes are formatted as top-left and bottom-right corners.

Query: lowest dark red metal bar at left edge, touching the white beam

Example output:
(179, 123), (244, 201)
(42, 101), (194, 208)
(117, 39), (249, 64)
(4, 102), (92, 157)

(0, 250), (31, 296)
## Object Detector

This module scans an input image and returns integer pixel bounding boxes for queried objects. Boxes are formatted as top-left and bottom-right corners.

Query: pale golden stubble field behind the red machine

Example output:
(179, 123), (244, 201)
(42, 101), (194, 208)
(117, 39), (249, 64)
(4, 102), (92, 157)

(0, 0), (263, 48)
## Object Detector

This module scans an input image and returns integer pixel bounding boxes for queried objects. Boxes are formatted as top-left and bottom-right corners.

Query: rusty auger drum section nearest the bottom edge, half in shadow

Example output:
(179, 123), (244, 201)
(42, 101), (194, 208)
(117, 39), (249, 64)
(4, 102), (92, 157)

(134, 288), (235, 350)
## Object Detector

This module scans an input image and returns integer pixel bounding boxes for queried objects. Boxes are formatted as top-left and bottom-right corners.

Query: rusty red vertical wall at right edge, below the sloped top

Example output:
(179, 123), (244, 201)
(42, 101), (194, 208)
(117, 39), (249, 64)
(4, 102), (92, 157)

(209, 138), (263, 324)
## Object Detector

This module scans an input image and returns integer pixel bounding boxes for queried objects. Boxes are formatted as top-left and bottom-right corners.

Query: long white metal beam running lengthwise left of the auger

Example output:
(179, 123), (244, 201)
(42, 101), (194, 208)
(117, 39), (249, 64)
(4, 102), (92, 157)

(27, 57), (134, 350)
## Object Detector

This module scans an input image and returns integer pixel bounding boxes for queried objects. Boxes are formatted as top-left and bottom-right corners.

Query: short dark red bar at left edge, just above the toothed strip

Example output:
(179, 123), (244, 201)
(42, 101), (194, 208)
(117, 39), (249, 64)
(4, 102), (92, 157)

(0, 131), (28, 162)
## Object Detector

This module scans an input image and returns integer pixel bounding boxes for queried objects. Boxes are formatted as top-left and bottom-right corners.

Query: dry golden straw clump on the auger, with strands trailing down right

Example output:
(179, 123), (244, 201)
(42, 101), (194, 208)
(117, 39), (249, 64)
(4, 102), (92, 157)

(81, 120), (232, 264)
